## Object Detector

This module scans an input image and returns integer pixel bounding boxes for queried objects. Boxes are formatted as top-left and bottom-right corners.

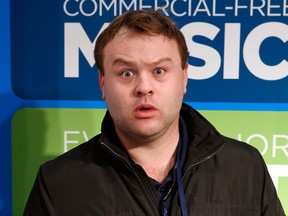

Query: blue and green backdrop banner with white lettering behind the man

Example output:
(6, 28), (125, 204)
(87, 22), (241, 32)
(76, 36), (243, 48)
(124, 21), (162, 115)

(0, 0), (288, 216)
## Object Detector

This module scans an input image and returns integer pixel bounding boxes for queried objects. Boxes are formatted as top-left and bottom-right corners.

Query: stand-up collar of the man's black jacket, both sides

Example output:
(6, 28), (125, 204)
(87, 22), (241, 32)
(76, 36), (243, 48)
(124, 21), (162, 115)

(100, 103), (225, 165)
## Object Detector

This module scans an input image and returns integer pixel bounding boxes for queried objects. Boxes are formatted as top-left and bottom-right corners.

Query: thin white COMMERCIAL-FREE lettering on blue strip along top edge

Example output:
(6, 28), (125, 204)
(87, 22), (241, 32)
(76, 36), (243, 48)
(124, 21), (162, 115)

(63, 0), (287, 17)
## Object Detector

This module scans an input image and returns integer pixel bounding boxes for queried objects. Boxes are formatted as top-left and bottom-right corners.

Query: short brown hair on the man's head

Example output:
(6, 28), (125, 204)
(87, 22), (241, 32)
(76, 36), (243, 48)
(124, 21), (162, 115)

(94, 10), (189, 74)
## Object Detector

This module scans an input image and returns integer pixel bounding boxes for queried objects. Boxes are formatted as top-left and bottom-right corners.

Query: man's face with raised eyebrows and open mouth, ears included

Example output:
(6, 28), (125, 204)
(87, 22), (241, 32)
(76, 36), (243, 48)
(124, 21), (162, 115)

(99, 29), (187, 141)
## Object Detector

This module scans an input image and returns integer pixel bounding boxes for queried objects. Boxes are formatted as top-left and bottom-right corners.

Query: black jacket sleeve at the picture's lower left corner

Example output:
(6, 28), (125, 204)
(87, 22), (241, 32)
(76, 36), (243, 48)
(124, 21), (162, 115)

(23, 168), (55, 216)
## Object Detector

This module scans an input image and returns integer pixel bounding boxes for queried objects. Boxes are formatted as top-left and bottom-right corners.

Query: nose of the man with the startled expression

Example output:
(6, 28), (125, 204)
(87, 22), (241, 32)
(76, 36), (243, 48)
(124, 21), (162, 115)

(135, 74), (154, 97)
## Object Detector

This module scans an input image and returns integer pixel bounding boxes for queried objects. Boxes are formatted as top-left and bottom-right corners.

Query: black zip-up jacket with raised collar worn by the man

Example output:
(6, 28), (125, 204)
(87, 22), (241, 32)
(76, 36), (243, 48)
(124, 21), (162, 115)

(24, 104), (285, 216)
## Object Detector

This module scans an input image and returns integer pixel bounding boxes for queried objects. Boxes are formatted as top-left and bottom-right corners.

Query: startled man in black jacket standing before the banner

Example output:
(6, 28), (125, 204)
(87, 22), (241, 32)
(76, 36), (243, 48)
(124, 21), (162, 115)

(24, 11), (284, 216)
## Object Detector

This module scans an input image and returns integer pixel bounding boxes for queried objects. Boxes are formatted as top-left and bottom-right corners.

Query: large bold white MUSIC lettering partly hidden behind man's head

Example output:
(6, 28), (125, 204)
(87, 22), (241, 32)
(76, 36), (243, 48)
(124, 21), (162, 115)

(64, 20), (288, 81)
